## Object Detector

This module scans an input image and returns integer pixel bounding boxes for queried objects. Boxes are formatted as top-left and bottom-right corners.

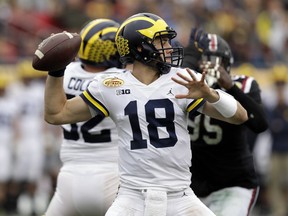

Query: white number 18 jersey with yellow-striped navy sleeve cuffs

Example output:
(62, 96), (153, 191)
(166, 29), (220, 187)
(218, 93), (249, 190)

(81, 68), (205, 191)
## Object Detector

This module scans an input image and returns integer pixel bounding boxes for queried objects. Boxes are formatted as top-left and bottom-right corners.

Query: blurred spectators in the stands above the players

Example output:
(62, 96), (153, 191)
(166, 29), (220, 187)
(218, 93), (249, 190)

(0, 0), (288, 67)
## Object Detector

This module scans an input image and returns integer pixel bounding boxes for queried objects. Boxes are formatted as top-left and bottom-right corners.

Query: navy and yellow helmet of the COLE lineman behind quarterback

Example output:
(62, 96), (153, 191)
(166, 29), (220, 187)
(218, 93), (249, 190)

(78, 19), (121, 67)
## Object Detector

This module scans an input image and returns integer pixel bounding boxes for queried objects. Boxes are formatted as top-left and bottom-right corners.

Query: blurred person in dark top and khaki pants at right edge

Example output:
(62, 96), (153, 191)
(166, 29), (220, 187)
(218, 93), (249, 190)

(263, 63), (288, 216)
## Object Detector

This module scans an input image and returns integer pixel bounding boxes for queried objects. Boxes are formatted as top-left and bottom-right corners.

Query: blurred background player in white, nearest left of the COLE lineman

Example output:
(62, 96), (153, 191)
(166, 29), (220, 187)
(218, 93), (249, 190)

(9, 59), (47, 215)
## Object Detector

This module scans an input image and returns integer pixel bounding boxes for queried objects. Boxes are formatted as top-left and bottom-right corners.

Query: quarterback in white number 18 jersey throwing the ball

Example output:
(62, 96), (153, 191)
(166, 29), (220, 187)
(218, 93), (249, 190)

(41, 13), (247, 216)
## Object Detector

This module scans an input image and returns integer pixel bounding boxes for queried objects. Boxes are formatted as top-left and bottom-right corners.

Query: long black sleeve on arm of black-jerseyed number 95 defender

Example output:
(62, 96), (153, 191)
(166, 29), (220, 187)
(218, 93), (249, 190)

(227, 84), (268, 133)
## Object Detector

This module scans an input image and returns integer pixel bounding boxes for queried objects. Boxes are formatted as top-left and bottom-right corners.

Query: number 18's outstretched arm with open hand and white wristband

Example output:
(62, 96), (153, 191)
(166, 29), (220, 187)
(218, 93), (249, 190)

(172, 68), (248, 124)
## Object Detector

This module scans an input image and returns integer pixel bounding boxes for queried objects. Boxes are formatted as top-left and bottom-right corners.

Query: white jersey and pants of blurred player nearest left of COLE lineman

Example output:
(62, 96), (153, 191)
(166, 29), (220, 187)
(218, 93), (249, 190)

(12, 80), (45, 182)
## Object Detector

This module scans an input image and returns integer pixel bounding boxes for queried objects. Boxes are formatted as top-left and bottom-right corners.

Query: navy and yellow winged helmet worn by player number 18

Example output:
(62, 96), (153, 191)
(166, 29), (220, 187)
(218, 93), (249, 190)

(116, 13), (183, 73)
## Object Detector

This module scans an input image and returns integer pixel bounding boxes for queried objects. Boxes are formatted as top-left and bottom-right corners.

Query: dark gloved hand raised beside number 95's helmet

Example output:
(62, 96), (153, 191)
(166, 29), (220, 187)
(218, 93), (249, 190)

(189, 28), (210, 53)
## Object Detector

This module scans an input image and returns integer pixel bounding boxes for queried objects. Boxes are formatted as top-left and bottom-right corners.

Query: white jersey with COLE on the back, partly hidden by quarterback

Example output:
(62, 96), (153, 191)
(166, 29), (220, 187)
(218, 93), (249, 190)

(60, 62), (123, 163)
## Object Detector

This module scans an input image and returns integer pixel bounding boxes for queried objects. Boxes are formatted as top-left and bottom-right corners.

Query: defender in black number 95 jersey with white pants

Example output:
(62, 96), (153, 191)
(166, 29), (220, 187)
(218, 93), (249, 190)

(183, 28), (268, 216)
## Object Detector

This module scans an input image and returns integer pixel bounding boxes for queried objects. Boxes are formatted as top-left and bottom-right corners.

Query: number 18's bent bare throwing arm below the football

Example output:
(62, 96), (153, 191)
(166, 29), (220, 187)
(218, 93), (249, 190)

(44, 69), (91, 125)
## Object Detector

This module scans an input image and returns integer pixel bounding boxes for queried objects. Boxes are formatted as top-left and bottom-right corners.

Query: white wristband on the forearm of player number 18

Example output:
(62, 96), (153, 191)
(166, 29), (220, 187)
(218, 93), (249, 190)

(211, 89), (237, 118)
